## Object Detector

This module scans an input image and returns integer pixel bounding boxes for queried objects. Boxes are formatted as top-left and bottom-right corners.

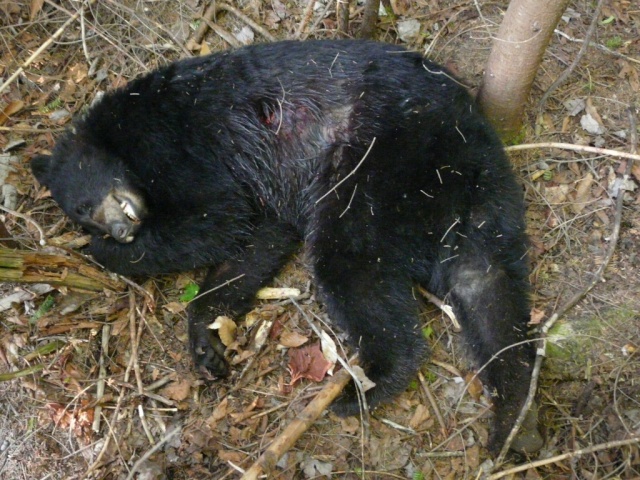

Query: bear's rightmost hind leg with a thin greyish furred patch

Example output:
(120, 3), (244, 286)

(448, 256), (541, 452)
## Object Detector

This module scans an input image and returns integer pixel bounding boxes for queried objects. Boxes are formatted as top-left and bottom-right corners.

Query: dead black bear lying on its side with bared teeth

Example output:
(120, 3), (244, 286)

(31, 41), (534, 449)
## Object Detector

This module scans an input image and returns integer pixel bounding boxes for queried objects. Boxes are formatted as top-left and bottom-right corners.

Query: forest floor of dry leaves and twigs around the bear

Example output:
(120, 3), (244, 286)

(0, 0), (640, 480)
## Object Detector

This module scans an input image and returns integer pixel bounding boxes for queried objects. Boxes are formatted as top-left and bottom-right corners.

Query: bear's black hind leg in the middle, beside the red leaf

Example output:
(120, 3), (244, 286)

(315, 255), (428, 416)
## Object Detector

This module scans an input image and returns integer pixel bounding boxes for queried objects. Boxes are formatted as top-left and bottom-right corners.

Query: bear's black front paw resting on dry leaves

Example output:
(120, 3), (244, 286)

(189, 324), (229, 380)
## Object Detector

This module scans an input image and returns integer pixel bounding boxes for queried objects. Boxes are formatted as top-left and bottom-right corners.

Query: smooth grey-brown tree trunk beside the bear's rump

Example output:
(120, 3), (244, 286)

(478, 0), (569, 140)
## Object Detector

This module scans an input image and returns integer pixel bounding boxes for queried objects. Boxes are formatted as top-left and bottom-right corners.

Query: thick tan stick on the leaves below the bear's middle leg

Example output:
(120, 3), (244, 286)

(242, 369), (351, 480)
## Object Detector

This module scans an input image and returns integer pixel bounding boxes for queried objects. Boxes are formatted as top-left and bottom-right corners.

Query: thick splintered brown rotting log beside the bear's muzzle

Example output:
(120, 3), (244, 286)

(0, 248), (124, 292)
